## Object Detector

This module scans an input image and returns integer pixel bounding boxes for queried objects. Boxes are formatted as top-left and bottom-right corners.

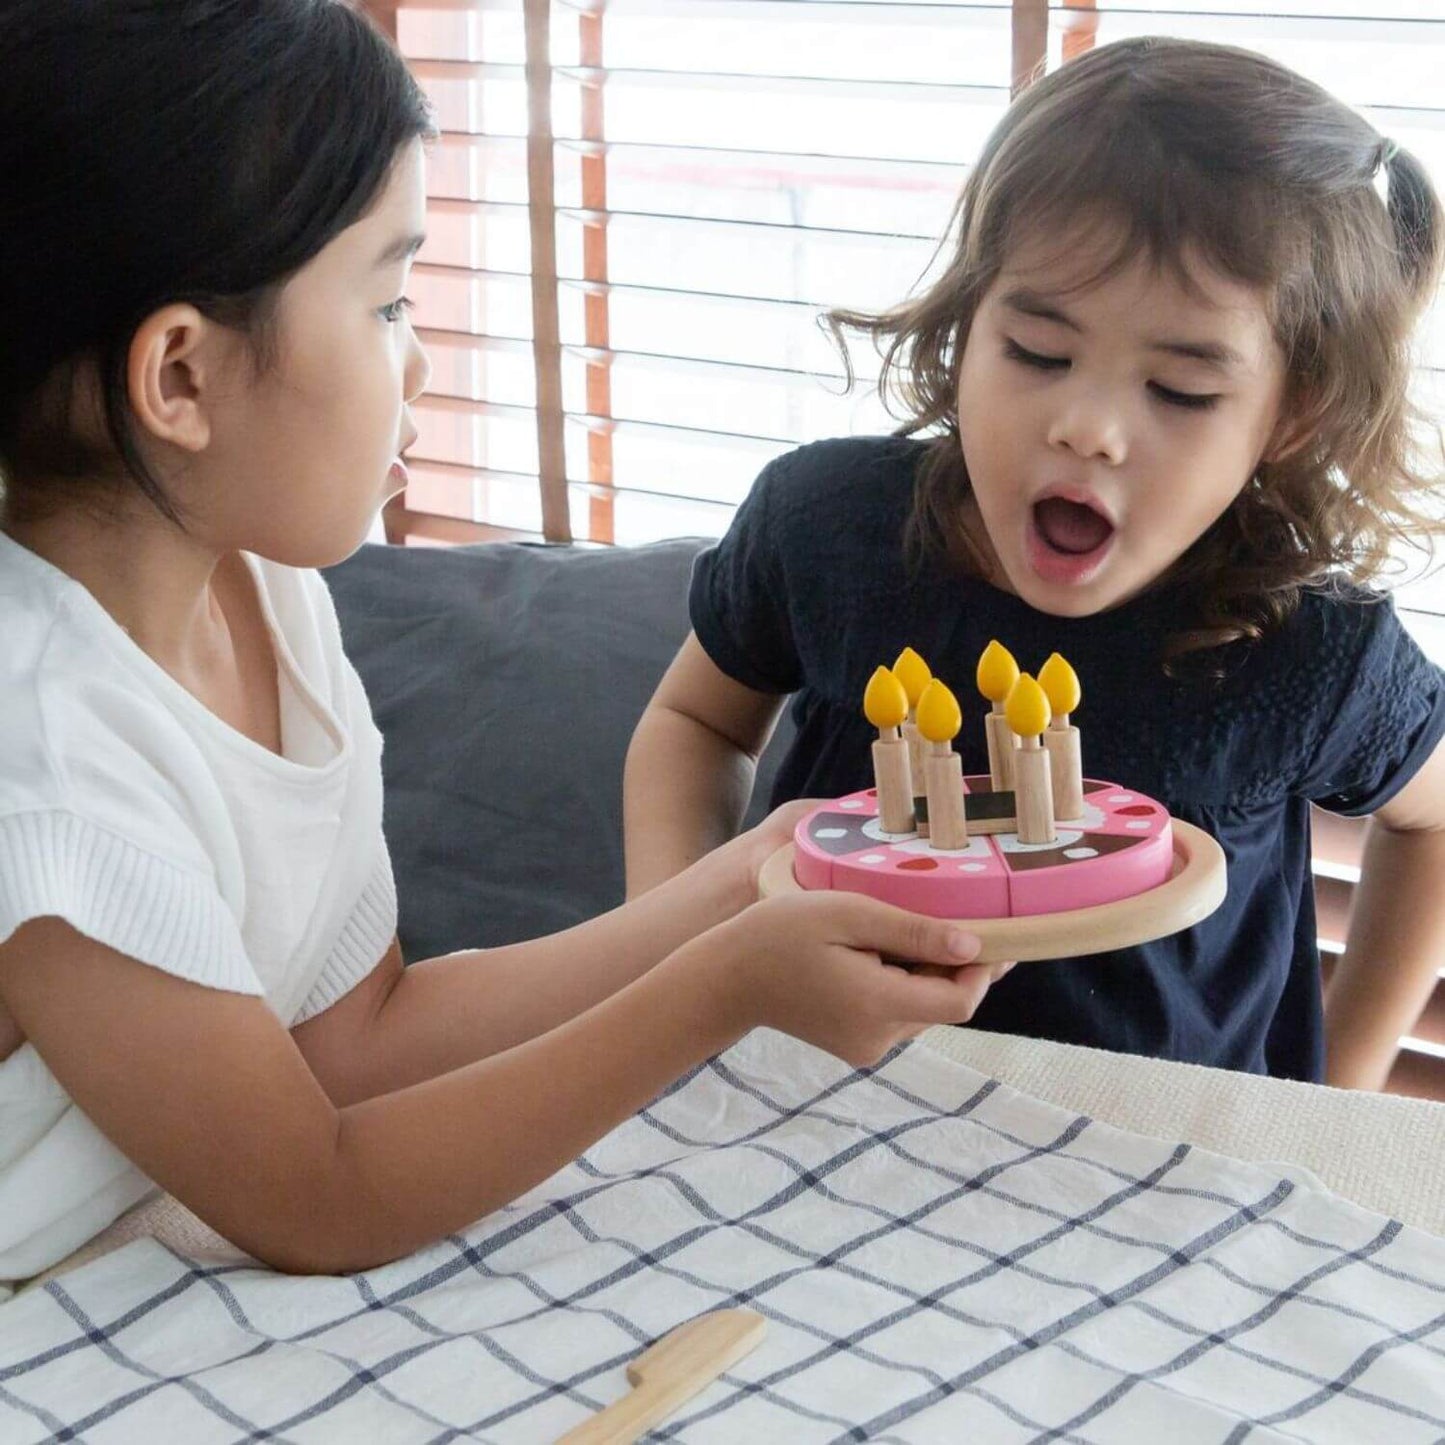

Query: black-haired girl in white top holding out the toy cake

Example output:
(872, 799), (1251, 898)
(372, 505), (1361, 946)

(0, 0), (996, 1286)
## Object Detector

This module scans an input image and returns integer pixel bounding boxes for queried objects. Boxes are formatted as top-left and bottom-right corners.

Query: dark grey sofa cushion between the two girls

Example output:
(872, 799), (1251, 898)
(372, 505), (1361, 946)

(327, 538), (785, 959)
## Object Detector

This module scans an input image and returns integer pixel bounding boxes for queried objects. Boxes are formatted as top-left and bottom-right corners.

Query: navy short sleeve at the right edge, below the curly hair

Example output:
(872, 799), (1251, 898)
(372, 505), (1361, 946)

(1301, 600), (1445, 815)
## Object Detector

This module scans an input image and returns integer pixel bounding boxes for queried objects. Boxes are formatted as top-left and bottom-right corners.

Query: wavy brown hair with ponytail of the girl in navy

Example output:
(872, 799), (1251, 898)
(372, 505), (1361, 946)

(827, 38), (1442, 656)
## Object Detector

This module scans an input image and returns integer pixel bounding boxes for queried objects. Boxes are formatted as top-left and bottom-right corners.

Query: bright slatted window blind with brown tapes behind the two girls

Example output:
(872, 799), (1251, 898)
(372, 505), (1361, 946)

(371, 0), (1445, 1098)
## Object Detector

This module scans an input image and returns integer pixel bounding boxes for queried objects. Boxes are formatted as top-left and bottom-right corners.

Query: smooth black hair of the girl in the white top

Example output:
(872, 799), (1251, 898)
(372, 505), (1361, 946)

(0, 0), (435, 520)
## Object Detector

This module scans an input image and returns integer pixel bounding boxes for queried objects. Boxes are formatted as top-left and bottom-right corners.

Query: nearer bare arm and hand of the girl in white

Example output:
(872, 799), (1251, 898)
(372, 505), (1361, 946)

(0, 894), (990, 1272)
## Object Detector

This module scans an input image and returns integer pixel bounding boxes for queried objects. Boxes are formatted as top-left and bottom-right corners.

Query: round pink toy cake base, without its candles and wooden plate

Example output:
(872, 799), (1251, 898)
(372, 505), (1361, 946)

(793, 775), (1175, 919)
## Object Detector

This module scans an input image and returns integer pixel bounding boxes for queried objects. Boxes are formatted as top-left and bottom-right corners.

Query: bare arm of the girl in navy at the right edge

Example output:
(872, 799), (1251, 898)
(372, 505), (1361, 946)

(1325, 746), (1445, 1088)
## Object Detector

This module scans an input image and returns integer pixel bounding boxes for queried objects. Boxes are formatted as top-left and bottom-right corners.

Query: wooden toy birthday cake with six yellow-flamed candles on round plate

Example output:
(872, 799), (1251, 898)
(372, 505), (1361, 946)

(762, 642), (1224, 959)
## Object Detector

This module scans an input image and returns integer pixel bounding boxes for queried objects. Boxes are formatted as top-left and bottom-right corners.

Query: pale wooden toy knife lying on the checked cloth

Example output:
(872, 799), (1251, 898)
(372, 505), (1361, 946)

(556, 1309), (767, 1445)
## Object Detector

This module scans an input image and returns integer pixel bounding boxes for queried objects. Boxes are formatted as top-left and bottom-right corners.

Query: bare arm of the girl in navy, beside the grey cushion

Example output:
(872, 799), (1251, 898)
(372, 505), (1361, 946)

(623, 633), (783, 897)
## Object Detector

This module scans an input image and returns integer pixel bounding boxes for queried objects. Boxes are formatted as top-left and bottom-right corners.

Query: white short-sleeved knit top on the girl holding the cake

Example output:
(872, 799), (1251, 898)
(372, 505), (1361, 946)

(0, 533), (396, 1298)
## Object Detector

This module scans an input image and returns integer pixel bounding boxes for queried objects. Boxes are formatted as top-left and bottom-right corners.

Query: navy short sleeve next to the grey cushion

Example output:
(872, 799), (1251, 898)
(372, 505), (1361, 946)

(688, 457), (802, 694)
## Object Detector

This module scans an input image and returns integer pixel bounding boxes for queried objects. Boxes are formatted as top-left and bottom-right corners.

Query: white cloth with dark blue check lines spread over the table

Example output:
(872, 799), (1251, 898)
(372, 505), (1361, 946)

(0, 1032), (1445, 1445)
